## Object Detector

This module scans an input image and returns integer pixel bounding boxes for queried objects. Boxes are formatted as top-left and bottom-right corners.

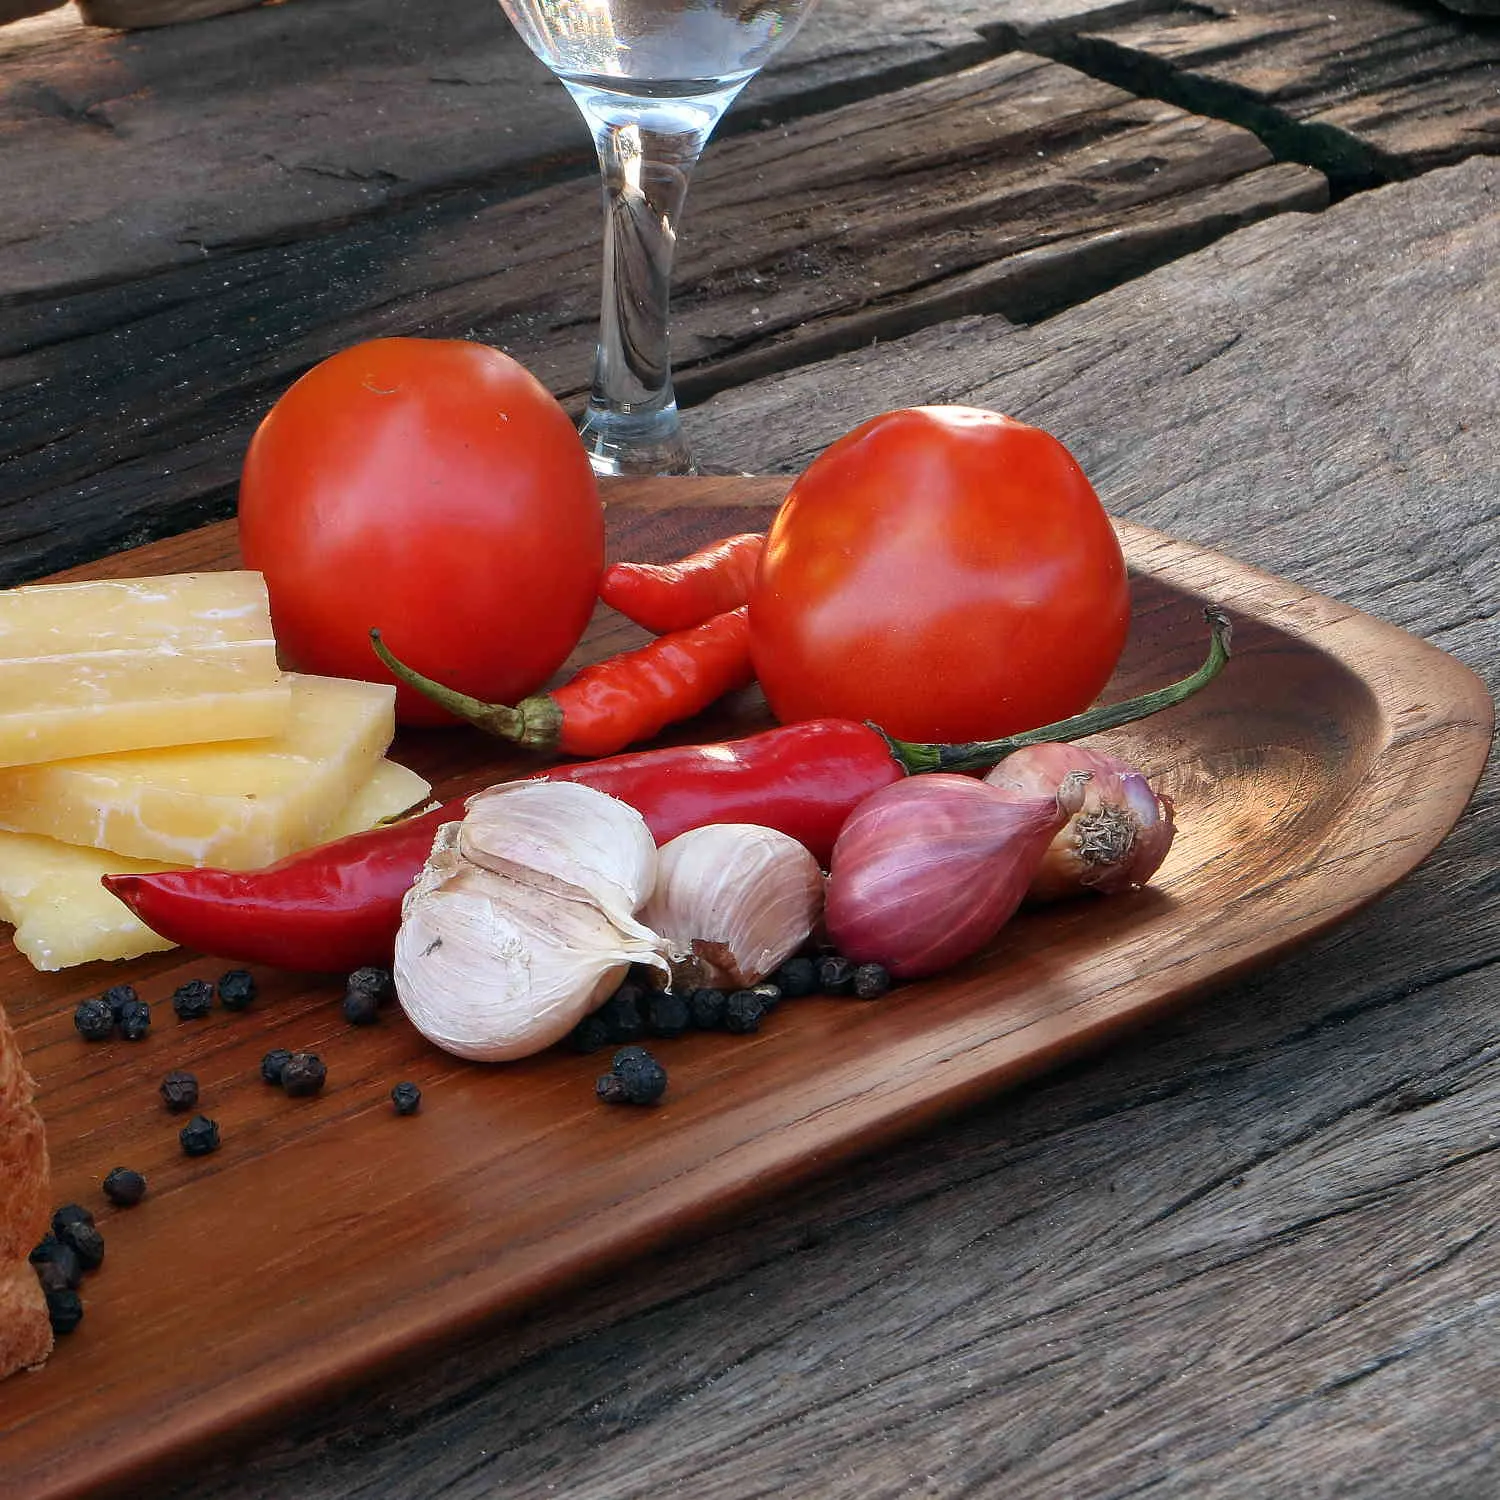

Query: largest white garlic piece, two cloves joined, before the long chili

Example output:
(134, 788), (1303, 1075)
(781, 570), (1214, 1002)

(393, 783), (668, 1062)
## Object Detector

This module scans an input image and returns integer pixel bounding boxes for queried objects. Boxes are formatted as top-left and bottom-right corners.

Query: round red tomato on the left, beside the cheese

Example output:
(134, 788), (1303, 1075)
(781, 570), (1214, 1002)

(240, 339), (605, 723)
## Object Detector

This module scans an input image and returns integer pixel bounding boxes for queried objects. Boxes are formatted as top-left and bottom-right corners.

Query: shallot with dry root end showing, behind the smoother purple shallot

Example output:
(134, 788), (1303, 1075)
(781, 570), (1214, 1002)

(984, 744), (1176, 902)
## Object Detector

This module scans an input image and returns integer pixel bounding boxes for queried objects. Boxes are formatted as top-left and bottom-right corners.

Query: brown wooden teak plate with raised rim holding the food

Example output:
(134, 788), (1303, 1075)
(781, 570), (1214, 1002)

(0, 479), (1493, 1500)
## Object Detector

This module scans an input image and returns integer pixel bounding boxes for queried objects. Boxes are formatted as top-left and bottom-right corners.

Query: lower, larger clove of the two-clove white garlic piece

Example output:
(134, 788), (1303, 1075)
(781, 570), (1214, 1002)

(393, 824), (666, 1062)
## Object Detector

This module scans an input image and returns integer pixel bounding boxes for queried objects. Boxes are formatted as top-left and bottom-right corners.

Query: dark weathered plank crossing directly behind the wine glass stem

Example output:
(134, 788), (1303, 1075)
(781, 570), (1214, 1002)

(0, 54), (1325, 582)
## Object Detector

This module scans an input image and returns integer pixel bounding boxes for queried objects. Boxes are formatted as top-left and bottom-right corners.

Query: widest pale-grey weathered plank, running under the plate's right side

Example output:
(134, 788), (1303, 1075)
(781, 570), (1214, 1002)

(155, 162), (1500, 1500)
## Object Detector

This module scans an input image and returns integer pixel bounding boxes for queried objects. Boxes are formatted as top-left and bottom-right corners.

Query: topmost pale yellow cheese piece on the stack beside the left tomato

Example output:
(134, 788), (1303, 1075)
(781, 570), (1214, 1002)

(0, 572), (291, 767)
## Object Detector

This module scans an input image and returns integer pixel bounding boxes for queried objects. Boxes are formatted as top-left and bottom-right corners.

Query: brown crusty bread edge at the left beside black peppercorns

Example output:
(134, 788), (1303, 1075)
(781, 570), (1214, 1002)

(0, 1007), (53, 1379)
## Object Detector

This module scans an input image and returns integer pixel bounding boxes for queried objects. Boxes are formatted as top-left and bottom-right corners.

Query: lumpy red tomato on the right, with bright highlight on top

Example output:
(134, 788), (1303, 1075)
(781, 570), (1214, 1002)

(750, 407), (1130, 741)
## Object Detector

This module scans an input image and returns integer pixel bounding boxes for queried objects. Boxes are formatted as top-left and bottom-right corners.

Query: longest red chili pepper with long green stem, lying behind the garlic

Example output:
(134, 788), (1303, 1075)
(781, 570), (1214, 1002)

(104, 609), (1230, 972)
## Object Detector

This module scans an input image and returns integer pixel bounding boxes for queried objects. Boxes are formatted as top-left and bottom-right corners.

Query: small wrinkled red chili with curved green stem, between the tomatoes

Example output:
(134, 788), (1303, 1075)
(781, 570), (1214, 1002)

(371, 608), (755, 756)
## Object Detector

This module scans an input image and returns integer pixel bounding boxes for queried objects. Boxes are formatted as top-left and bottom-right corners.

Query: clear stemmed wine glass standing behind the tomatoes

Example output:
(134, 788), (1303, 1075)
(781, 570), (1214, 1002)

(501, 0), (816, 474)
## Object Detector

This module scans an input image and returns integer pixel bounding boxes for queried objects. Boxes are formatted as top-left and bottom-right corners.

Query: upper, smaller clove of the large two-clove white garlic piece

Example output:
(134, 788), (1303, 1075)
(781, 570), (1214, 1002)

(459, 782), (657, 927)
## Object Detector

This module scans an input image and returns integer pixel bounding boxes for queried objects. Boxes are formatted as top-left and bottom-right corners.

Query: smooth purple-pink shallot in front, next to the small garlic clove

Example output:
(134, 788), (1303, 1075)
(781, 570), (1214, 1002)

(825, 773), (1086, 980)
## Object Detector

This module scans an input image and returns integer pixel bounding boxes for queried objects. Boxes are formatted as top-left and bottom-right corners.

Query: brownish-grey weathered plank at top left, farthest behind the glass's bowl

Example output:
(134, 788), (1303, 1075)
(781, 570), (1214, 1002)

(0, 0), (993, 305)
